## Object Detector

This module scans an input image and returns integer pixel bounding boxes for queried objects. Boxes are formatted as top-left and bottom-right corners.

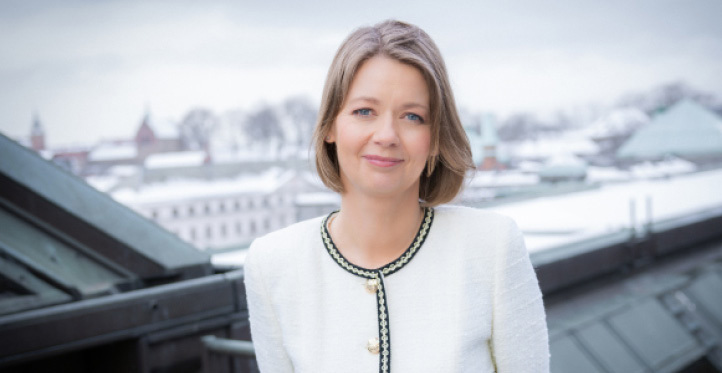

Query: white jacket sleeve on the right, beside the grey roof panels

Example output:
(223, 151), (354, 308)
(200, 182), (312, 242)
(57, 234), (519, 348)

(490, 219), (549, 373)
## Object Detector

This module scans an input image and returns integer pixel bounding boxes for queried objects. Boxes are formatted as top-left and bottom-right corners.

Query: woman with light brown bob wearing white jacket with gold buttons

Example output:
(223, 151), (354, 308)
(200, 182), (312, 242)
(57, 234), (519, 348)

(245, 21), (549, 373)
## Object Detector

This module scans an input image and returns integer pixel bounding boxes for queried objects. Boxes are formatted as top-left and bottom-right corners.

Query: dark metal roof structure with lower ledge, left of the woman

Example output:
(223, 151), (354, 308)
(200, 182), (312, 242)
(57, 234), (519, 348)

(0, 135), (250, 373)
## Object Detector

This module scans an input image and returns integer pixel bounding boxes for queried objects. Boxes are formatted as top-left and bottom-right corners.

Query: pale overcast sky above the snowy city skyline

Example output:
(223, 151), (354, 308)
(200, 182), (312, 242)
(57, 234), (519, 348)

(0, 0), (722, 145)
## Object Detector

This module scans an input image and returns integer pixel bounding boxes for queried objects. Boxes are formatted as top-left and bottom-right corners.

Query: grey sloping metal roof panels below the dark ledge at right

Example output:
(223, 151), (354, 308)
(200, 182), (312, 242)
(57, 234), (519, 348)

(546, 232), (722, 373)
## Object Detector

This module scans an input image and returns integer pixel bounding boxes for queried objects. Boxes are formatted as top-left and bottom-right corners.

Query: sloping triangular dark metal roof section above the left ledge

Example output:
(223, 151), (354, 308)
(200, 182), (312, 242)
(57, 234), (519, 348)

(0, 135), (212, 315)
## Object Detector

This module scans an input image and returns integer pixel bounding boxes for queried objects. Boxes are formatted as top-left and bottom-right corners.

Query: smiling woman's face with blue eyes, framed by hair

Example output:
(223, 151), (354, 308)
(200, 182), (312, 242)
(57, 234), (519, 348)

(326, 56), (431, 198)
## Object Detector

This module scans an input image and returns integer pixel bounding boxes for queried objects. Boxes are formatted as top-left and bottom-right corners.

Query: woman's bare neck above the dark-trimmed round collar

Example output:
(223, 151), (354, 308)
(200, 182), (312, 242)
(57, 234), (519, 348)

(330, 195), (423, 268)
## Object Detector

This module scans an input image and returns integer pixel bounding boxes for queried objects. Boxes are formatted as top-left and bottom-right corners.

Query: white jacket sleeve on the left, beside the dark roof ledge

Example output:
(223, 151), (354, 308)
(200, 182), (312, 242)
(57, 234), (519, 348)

(244, 240), (293, 373)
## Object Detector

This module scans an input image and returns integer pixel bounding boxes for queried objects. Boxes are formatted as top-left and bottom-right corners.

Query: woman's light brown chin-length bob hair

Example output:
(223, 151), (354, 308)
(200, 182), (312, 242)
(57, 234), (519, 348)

(313, 20), (474, 206)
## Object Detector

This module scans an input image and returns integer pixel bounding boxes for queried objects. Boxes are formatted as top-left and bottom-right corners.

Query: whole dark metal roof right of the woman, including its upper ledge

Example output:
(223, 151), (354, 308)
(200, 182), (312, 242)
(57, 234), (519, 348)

(531, 179), (722, 373)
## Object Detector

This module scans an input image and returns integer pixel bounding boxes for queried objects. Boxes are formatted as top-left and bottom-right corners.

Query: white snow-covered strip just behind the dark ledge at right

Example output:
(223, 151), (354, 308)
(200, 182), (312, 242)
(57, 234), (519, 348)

(489, 170), (722, 252)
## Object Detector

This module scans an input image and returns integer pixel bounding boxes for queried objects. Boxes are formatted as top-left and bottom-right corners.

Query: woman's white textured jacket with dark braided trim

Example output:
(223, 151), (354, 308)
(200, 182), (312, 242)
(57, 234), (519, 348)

(245, 206), (549, 373)
